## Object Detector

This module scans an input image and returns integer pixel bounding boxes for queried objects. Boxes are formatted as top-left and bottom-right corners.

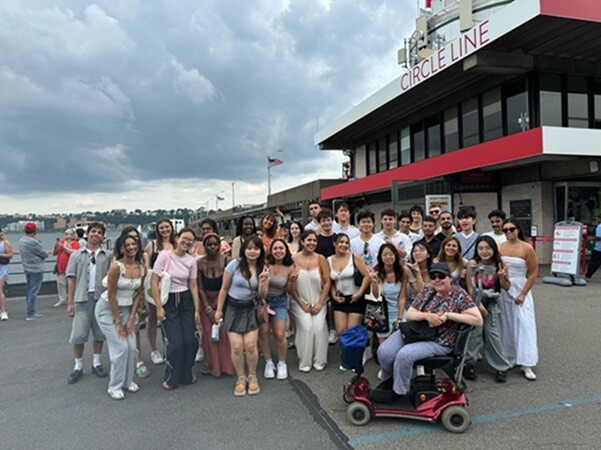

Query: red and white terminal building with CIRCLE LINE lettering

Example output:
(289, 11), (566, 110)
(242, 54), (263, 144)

(315, 0), (601, 263)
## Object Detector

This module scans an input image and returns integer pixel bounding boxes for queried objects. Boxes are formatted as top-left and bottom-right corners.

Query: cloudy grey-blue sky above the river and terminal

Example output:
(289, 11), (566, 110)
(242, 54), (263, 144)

(0, 0), (416, 213)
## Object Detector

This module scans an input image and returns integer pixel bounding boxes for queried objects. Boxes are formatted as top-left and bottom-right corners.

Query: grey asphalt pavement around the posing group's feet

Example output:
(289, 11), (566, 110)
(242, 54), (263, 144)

(0, 274), (601, 449)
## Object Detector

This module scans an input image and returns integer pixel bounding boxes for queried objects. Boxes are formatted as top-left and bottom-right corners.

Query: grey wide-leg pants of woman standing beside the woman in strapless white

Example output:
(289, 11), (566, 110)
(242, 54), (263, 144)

(465, 302), (512, 372)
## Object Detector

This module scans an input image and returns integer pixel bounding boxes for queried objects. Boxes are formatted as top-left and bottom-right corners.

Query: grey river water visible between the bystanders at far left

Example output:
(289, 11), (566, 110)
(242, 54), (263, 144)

(4, 230), (121, 284)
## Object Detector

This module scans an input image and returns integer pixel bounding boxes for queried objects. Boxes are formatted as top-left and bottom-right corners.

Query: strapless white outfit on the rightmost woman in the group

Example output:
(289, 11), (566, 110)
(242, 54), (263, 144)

(499, 256), (538, 367)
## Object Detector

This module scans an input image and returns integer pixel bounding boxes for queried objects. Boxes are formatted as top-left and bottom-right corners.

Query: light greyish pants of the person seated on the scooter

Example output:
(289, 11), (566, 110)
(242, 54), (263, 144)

(378, 330), (452, 395)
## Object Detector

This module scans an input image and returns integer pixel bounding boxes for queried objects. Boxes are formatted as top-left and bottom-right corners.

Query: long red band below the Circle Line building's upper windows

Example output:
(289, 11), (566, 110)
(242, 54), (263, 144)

(321, 127), (543, 200)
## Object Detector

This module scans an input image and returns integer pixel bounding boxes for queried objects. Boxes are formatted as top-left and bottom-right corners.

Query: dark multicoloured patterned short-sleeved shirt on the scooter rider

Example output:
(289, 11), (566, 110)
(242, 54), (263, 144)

(411, 285), (476, 347)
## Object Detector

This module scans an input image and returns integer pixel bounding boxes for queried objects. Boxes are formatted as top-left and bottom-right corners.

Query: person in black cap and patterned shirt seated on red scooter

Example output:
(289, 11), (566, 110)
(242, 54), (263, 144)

(371, 263), (482, 403)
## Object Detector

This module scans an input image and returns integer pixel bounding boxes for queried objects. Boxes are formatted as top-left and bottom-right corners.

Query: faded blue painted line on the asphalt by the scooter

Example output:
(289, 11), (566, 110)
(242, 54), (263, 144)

(348, 394), (601, 448)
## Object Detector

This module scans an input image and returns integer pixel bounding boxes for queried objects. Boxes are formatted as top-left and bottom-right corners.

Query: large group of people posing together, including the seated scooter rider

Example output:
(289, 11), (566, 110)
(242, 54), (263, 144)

(0, 202), (538, 401)
